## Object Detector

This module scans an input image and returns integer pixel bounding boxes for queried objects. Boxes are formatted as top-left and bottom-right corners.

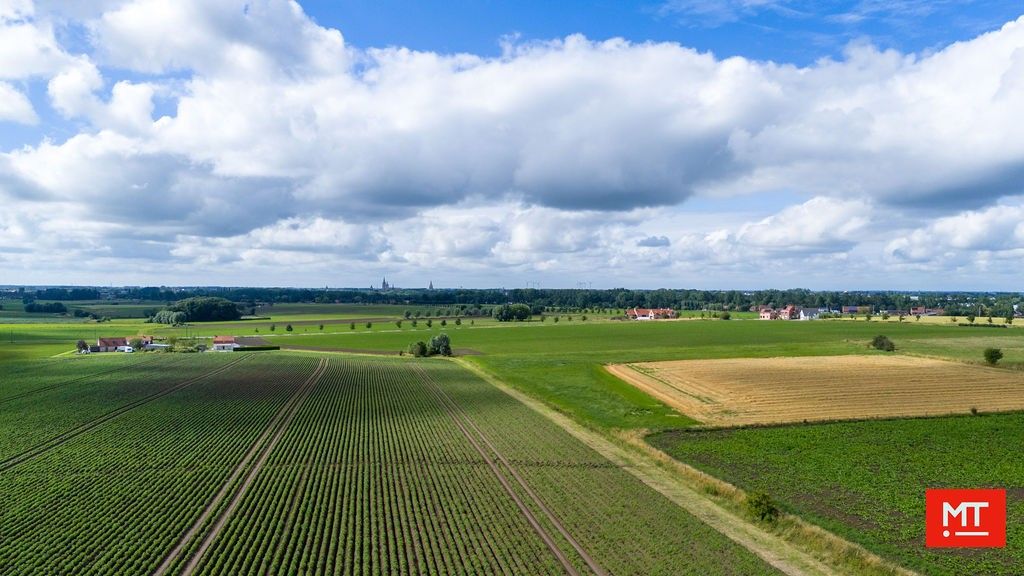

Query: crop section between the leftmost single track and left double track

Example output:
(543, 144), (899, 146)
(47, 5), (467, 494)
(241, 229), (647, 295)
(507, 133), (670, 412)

(0, 355), (316, 574)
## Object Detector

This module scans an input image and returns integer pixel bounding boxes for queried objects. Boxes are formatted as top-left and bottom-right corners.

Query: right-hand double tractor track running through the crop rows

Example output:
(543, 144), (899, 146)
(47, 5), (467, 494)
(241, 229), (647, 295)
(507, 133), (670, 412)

(416, 366), (608, 576)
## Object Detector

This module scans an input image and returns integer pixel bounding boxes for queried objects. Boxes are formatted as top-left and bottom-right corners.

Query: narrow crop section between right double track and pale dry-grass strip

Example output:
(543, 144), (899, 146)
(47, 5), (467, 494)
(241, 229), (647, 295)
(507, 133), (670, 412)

(430, 365), (775, 575)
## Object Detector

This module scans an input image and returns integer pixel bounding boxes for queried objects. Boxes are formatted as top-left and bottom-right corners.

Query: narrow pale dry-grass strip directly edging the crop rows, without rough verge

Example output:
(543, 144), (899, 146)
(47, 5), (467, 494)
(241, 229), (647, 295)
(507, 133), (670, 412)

(455, 360), (867, 576)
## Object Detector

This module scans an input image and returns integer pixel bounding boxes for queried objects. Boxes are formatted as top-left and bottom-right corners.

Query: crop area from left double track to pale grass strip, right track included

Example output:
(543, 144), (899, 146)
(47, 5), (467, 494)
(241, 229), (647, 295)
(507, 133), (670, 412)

(182, 359), (774, 575)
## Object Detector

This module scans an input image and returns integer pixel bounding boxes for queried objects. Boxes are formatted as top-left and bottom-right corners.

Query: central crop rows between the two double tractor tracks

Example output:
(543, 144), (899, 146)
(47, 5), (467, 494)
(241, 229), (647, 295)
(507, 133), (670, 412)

(192, 360), (561, 574)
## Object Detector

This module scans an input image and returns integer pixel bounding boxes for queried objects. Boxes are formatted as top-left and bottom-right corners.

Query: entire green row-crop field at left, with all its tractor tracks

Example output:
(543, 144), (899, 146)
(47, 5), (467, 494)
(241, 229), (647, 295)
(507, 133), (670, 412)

(0, 353), (775, 575)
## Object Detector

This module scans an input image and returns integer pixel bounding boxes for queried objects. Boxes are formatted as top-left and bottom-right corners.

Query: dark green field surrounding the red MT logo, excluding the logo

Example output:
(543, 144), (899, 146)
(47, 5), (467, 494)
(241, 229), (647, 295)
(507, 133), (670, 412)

(648, 413), (1024, 576)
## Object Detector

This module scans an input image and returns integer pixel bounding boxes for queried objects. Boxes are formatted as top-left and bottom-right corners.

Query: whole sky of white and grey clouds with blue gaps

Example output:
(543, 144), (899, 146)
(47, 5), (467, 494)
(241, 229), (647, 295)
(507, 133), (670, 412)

(0, 0), (1024, 290)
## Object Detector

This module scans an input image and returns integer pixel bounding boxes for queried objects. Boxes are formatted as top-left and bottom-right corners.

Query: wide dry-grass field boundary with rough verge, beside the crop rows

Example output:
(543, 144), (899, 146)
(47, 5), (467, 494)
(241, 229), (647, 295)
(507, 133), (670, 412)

(452, 359), (897, 576)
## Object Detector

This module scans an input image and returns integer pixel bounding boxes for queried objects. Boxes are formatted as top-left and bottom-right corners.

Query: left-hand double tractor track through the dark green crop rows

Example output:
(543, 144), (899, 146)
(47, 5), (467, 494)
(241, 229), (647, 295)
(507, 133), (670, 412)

(161, 358), (328, 576)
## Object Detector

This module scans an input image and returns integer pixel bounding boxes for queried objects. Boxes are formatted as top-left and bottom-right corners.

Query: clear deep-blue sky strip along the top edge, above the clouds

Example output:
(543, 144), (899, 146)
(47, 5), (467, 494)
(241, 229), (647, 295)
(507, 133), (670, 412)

(303, 0), (1021, 66)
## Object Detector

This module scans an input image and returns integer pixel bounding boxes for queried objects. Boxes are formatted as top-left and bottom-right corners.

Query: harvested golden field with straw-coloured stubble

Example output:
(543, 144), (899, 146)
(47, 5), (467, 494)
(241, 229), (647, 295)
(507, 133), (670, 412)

(608, 356), (1024, 426)
